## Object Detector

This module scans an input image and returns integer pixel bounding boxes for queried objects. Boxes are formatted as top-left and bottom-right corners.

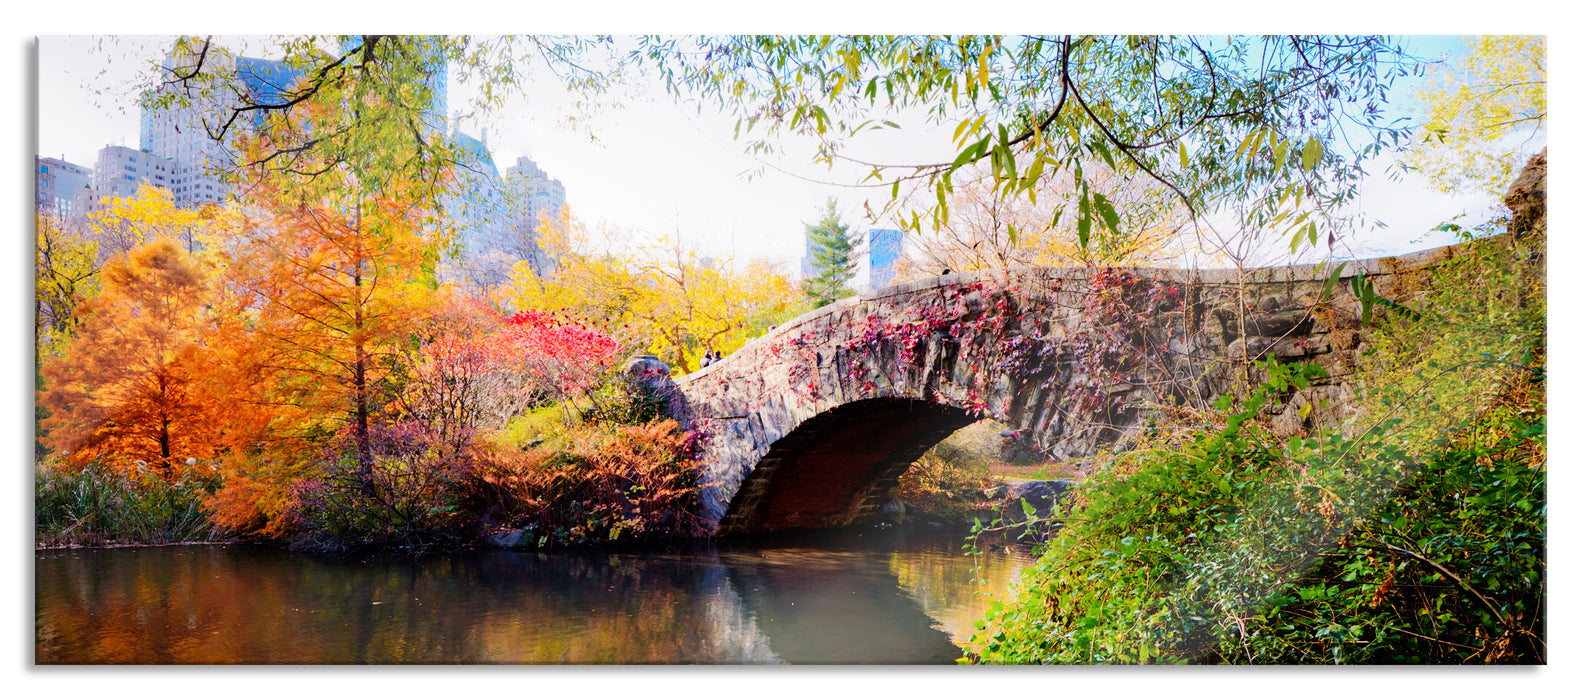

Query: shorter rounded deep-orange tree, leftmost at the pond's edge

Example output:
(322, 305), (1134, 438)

(40, 239), (223, 474)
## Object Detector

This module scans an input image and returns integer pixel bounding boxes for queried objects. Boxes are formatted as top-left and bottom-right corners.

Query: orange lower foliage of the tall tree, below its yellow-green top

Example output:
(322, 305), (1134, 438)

(196, 173), (449, 534)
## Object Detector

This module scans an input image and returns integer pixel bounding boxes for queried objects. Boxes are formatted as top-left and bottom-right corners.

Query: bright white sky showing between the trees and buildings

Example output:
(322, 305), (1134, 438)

(27, 35), (1531, 271)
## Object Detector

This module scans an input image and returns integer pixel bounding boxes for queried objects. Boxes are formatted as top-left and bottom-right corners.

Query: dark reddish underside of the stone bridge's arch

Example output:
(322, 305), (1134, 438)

(718, 398), (978, 535)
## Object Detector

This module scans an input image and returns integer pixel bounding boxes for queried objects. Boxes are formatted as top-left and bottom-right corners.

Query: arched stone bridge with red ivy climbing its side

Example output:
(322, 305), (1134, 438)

(654, 240), (1465, 535)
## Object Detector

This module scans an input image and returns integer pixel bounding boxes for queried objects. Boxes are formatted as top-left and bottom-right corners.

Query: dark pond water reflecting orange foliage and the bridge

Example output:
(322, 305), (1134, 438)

(33, 529), (1028, 664)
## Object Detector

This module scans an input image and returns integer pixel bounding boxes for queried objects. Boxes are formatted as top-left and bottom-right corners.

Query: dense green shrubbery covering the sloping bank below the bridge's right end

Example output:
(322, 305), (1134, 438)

(970, 239), (1547, 664)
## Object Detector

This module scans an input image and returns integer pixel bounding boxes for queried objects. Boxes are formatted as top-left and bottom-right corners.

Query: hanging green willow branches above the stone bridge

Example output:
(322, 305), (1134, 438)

(633, 35), (1417, 254)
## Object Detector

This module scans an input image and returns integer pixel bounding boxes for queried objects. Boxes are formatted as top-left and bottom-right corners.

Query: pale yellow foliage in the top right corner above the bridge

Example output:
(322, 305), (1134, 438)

(1403, 36), (1549, 196)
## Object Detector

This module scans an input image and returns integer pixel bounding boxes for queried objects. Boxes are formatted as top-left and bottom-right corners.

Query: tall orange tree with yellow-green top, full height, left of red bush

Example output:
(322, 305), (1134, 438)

(181, 54), (468, 532)
